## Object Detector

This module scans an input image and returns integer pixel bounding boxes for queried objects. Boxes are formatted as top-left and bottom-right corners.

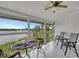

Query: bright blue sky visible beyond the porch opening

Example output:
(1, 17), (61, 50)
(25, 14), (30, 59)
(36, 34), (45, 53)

(0, 18), (39, 29)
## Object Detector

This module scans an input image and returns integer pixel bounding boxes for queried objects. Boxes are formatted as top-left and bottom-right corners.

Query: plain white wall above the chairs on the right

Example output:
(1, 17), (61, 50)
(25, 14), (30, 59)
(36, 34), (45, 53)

(54, 1), (79, 34)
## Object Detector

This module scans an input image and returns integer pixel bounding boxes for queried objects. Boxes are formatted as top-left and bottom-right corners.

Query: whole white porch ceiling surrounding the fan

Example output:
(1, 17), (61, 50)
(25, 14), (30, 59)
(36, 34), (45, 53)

(0, 1), (79, 21)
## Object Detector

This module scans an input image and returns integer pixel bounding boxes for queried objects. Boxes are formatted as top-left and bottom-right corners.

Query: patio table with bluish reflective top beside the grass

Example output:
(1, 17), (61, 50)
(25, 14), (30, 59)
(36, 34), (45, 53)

(12, 41), (38, 58)
